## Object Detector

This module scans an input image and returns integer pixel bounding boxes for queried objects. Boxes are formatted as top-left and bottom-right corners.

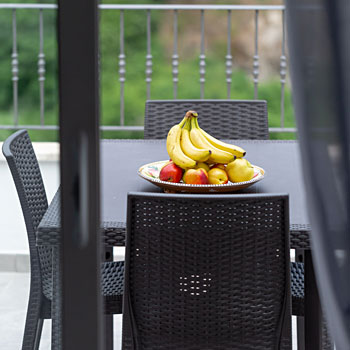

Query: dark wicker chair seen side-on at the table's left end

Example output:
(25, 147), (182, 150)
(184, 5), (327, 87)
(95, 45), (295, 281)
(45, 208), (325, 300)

(2, 130), (124, 350)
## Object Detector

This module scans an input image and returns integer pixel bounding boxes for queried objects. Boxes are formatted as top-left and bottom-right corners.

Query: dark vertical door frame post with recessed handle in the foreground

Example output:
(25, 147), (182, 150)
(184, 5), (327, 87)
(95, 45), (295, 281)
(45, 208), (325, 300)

(58, 0), (104, 350)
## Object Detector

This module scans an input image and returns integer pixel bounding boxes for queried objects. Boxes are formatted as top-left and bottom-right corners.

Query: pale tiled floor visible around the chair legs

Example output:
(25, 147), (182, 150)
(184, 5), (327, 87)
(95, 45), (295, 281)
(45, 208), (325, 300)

(0, 272), (296, 350)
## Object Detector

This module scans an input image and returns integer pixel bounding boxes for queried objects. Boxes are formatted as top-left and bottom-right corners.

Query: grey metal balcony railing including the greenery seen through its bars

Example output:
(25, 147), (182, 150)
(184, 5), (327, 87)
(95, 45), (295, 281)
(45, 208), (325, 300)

(0, 4), (296, 140)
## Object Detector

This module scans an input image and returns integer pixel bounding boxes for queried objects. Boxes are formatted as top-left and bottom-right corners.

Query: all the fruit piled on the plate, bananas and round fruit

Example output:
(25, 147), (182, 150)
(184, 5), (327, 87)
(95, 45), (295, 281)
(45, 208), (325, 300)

(159, 111), (254, 185)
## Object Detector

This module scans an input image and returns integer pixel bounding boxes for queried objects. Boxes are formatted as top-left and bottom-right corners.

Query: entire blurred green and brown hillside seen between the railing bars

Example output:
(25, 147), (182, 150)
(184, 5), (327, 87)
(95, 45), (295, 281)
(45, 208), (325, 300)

(0, 0), (296, 141)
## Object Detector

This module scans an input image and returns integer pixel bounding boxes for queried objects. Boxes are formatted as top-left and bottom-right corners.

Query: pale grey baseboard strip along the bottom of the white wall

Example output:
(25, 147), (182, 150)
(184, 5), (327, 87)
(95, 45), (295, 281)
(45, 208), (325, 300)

(0, 247), (125, 272)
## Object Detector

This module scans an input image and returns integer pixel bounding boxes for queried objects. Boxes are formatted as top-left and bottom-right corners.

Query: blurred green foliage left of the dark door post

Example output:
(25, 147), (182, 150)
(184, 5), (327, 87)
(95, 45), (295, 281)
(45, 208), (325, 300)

(0, 0), (58, 140)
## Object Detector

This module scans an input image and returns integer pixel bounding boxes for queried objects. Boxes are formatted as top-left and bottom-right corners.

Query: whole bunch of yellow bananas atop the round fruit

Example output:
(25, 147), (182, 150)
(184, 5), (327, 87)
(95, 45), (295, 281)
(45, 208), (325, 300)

(167, 111), (246, 169)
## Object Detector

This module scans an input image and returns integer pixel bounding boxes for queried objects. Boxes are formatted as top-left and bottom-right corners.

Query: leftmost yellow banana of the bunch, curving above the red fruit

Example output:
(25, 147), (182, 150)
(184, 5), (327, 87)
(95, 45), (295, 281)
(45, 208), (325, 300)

(166, 117), (197, 169)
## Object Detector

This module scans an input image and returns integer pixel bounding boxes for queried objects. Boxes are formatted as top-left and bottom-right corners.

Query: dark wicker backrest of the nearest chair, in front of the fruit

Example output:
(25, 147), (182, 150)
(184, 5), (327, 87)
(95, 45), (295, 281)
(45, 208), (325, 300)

(123, 193), (290, 350)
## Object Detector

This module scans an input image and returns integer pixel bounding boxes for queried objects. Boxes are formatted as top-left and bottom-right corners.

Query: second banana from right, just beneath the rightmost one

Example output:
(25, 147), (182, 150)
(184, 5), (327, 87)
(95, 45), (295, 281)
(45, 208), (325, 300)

(190, 118), (236, 164)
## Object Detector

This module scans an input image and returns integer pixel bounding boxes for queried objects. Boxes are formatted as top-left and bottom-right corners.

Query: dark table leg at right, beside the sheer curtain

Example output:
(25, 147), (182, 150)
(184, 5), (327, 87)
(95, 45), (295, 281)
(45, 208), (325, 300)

(304, 250), (322, 350)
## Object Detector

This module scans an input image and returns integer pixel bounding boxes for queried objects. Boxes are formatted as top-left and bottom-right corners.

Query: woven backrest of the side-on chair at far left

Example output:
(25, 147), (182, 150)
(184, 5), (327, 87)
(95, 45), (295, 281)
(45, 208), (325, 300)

(2, 130), (52, 298)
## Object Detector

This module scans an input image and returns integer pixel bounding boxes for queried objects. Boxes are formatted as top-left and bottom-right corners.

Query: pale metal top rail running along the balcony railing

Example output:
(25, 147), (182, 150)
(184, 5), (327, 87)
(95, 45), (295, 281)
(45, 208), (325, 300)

(0, 4), (285, 11)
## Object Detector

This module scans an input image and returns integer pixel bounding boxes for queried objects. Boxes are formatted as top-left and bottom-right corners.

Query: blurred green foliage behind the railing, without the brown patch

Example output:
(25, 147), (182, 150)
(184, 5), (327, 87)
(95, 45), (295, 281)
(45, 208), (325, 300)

(0, 0), (295, 140)
